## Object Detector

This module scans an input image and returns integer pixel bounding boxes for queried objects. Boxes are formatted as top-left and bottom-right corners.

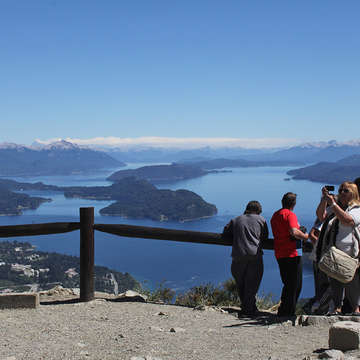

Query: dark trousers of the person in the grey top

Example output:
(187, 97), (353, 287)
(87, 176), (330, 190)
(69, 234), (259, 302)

(231, 255), (264, 314)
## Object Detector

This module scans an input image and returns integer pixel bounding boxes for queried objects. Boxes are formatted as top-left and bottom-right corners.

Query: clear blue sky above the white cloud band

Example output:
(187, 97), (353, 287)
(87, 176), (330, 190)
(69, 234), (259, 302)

(0, 0), (360, 144)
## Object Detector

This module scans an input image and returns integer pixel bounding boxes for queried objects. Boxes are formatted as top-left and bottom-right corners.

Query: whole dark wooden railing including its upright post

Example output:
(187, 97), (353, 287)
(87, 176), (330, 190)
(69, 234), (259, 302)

(0, 207), (273, 301)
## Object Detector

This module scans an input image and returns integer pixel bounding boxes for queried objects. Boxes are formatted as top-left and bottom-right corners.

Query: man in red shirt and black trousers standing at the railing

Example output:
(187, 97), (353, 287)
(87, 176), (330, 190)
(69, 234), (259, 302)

(271, 192), (308, 316)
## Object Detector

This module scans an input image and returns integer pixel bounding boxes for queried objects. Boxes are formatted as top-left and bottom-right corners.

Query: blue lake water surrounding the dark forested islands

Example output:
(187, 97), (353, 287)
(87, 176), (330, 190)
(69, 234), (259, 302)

(0, 164), (328, 298)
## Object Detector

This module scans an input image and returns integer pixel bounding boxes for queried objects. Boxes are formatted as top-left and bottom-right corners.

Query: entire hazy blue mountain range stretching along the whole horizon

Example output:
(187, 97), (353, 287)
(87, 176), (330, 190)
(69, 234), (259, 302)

(0, 140), (360, 182)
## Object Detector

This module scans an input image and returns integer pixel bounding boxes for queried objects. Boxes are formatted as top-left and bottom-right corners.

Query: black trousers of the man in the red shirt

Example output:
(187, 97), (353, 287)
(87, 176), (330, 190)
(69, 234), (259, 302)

(277, 256), (302, 316)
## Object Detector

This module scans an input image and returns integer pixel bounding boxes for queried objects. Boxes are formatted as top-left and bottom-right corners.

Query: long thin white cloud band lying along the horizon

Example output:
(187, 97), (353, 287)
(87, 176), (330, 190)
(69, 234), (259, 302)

(36, 136), (301, 149)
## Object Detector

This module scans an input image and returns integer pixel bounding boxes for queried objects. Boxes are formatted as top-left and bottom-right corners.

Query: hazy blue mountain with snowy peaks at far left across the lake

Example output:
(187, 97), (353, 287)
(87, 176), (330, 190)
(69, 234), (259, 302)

(0, 141), (125, 176)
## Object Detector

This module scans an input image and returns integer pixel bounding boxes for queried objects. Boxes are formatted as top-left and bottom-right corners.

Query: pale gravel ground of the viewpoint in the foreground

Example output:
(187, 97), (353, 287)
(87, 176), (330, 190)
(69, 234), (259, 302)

(0, 292), (350, 360)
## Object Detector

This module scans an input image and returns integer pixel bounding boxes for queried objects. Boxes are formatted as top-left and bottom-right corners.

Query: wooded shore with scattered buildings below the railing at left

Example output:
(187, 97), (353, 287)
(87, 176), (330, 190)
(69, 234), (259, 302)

(0, 241), (140, 293)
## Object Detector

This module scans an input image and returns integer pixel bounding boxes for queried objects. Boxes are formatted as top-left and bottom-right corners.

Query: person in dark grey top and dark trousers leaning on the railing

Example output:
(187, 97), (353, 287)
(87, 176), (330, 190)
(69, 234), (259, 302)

(223, 201), (269, 316)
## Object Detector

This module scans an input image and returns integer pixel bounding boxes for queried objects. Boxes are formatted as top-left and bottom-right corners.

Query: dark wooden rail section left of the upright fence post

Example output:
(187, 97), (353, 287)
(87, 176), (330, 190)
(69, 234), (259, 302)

(0, 222), (80, 238)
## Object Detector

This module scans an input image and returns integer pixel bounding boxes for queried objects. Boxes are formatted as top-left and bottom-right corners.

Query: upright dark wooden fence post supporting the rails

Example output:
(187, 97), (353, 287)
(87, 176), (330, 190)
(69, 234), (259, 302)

(80, 207), (95, 301)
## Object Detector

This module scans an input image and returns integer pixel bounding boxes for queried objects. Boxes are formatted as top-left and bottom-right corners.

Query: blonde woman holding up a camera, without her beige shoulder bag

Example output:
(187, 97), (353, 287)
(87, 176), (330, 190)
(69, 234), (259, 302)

(316, 181), (360, 314)
